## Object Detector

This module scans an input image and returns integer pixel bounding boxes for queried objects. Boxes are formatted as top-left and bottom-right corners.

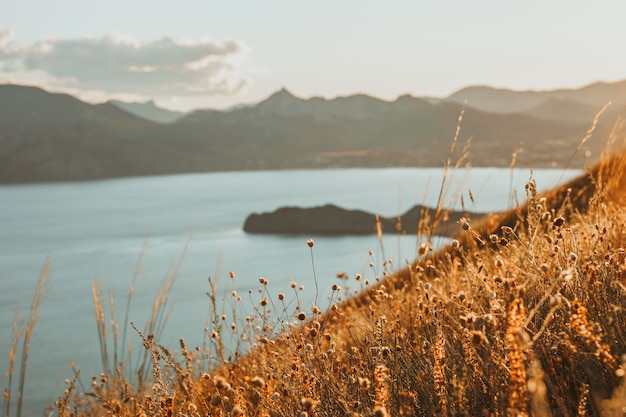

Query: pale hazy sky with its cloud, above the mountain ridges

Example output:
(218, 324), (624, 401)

(0, 0), (626, 111)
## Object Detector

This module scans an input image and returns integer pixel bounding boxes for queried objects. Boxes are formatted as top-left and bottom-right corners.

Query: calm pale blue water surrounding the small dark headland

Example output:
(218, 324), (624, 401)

(0, 168), (579, 415)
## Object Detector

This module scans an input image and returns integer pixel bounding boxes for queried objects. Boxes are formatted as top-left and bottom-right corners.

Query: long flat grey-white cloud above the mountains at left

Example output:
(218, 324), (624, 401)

(0, 28), (249, 96)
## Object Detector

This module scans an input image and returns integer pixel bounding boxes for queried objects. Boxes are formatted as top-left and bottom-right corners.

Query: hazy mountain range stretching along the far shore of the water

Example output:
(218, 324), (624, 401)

(0, 81), (626, 183)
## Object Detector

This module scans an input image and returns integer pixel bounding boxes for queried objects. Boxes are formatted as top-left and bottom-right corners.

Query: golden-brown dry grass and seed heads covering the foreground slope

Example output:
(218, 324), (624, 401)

(3, 122), (626, 417)
